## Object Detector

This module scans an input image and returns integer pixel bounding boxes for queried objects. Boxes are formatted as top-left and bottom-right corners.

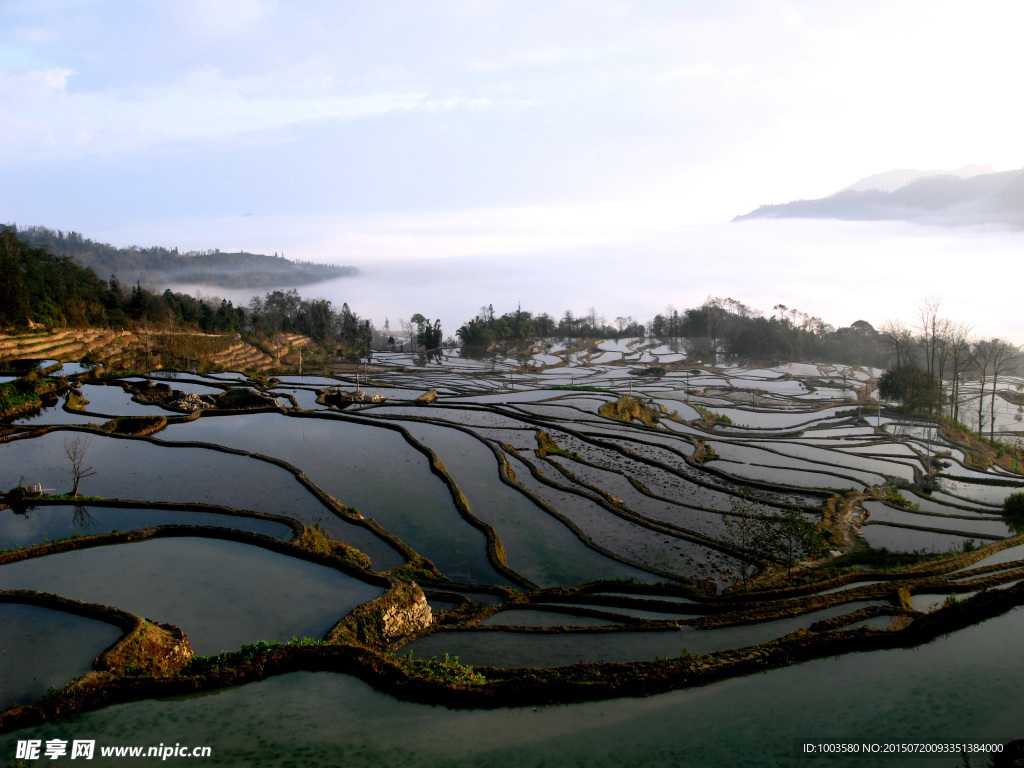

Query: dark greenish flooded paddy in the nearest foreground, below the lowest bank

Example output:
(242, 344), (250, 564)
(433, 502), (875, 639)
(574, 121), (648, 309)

(6, 608), (1024, 768)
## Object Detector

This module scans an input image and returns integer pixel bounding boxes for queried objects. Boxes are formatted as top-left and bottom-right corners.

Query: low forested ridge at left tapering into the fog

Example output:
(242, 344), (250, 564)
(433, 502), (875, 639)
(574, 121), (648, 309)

(9, 226), (358, 288)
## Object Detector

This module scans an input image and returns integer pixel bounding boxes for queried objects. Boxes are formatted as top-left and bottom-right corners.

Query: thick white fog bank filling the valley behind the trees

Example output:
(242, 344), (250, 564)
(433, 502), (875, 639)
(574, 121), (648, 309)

(169, 220), (1024, 344)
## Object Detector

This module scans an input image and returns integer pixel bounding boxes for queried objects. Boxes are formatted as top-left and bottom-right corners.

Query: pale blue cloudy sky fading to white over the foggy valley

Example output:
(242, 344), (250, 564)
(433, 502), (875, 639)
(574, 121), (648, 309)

(0, 0), (1024, 343)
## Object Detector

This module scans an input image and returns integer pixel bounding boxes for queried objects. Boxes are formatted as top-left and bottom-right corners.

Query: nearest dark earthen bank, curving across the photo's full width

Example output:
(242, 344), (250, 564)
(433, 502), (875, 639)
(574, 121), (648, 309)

(0, 585), (1024, 733)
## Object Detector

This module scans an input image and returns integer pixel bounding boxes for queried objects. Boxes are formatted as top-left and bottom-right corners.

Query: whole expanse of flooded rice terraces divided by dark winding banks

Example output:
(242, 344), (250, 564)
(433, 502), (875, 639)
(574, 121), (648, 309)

(0, 350), (1024, 765)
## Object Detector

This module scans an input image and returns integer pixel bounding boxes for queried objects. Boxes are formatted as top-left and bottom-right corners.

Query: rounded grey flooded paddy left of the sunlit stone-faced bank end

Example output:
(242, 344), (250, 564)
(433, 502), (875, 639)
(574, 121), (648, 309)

(0, 537), (381, 653)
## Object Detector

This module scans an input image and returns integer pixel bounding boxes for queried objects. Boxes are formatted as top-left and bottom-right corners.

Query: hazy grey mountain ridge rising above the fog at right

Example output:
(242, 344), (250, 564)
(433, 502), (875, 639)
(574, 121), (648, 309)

(733, 166), (1024, 228)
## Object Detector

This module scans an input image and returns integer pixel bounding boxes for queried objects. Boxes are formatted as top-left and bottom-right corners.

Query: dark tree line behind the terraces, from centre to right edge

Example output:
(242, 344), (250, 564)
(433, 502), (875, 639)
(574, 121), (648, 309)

(457, 297), (1024, 439)
